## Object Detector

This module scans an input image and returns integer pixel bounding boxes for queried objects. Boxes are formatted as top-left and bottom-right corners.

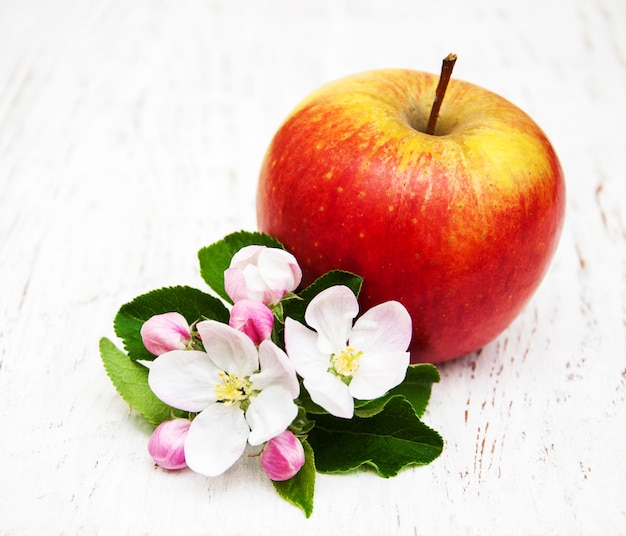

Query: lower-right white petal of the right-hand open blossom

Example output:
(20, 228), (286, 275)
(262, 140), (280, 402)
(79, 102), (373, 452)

(349, 352), (411, 400)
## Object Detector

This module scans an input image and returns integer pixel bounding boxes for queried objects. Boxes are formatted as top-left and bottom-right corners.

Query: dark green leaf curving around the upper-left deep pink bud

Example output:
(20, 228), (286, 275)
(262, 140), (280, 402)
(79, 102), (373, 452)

(113, 286), (229, 361)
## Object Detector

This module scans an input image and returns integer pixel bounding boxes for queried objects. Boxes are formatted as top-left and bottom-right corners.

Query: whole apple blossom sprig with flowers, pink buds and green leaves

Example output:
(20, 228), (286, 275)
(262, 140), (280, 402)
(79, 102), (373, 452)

(100, 232), (443, 516)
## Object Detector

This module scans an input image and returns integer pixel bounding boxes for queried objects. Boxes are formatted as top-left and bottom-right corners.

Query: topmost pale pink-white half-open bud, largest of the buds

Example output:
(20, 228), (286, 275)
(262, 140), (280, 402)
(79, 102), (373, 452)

(224, 245), (302, 305)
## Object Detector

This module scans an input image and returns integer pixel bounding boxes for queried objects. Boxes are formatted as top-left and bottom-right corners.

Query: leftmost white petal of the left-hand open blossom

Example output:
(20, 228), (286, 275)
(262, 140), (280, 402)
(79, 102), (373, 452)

(148, 350), (219, 412)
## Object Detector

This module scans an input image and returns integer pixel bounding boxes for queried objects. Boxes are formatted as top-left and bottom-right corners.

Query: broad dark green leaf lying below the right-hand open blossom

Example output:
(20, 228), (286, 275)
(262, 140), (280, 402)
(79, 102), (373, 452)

(308, 396), (443, 478)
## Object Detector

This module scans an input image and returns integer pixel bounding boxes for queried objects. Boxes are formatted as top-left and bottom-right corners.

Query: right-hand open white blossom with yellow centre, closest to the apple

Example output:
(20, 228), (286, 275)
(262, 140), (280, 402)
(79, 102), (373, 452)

(285, 286), (411, 418)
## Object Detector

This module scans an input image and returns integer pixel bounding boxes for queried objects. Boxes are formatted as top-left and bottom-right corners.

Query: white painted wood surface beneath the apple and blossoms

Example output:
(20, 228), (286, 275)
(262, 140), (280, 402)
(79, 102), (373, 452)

(0, 0), (626, 535)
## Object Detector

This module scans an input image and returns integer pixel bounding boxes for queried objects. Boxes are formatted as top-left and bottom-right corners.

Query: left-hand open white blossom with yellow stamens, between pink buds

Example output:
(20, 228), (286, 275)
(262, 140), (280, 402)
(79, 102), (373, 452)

(148, 320), (300, 476)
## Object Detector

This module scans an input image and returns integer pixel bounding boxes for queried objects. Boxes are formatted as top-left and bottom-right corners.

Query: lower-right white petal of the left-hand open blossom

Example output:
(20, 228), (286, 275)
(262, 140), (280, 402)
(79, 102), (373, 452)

(246, 385), (298, 445)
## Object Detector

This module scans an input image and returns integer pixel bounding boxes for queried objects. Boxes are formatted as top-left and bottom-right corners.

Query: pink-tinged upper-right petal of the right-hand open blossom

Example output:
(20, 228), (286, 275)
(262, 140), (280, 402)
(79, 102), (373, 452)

(350, 301), (412, 353)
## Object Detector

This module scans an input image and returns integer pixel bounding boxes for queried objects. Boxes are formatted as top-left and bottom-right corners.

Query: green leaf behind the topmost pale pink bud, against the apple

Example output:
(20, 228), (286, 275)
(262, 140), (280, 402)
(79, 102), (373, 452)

(198, 231), (285, 303)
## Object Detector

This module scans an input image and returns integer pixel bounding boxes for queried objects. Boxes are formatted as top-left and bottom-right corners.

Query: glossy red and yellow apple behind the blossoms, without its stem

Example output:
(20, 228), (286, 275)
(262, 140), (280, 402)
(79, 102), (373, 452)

(257, 69), (565, 363)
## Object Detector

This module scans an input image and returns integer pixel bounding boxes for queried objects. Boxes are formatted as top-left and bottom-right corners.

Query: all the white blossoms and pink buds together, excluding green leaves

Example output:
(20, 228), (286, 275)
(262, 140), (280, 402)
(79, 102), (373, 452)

(141, 245), (411, 480)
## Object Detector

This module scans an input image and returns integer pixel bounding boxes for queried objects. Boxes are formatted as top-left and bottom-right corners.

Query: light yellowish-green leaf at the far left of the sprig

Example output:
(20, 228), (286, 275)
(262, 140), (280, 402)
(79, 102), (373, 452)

(100, 338), (172, 426)
